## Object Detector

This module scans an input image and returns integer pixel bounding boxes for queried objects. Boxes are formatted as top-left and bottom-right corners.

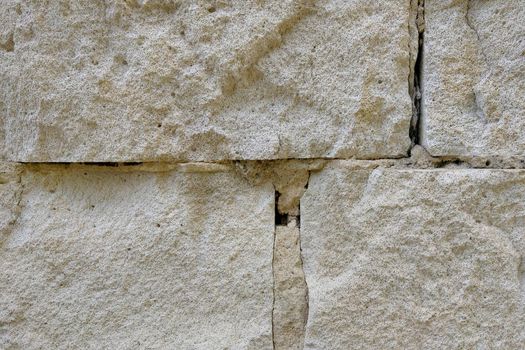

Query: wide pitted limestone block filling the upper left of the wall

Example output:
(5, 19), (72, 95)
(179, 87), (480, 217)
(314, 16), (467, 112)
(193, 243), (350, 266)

(0, 0), (411, 162)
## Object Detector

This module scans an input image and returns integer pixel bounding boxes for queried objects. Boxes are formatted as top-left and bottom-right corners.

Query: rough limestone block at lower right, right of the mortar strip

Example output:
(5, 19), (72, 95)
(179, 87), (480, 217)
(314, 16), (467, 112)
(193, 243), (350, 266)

(301, 166), (525, 349)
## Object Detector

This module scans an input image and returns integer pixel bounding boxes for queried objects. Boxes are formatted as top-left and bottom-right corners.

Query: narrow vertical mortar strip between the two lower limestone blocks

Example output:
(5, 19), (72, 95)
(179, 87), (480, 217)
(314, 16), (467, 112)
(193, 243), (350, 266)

(273, 219), (308, 350)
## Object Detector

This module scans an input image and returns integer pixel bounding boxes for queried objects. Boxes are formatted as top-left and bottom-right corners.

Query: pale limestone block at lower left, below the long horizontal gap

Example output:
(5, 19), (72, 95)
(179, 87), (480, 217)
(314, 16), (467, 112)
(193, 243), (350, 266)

(0, 167), (274, 349)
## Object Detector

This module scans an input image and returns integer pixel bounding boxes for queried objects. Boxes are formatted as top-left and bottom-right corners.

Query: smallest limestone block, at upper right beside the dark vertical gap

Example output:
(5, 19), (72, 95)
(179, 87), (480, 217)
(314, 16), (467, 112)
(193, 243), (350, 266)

(421, 0), (525, 156)
